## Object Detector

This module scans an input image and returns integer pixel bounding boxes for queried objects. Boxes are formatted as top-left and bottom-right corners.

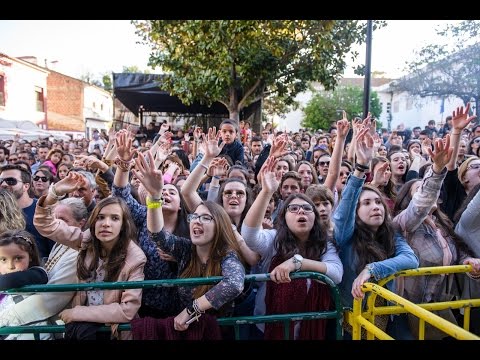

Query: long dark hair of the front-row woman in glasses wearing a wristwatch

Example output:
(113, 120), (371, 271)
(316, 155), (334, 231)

(275, 193), (333, 260)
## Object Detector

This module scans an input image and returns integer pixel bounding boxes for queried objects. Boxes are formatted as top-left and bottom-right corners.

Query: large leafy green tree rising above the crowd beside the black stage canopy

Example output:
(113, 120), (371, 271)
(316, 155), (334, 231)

(132, 20), (383, 121)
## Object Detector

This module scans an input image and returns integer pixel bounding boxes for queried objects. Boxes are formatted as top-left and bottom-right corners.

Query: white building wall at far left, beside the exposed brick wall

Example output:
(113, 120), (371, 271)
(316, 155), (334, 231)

(0, 56), (48, 124)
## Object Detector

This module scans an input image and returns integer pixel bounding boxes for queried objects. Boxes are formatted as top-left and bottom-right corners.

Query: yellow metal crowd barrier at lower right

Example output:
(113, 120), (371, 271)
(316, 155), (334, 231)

(345, 265), (480, 340)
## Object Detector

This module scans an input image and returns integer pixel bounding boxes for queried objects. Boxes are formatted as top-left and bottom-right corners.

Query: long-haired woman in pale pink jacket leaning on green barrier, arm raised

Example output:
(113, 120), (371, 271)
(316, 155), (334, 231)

(34, 172), (146, 340)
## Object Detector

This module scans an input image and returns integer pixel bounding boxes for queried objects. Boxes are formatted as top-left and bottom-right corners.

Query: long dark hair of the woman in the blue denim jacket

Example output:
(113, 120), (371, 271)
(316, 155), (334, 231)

(353, 185), (395, 273)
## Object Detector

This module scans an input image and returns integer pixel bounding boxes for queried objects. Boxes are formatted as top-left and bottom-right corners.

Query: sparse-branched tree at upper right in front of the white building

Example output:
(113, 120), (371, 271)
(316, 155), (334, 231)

(392, 20), (480, 114)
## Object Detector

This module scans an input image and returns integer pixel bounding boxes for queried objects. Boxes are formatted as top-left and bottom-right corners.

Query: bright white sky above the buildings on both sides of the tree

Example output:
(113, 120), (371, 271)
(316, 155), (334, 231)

(0, 20), (458, 79)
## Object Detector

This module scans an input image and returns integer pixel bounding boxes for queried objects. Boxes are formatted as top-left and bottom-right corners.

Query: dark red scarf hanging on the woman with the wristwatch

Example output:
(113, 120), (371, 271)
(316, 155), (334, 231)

(264, 256), (332, 340)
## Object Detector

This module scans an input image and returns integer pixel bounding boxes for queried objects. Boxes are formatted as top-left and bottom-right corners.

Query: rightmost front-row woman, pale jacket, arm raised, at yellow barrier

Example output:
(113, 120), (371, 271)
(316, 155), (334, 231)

(394, 134), (480, 340)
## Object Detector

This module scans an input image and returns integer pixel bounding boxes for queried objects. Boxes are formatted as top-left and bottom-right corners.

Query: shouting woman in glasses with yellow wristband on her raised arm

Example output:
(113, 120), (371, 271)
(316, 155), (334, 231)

(135, 150), (245, 331)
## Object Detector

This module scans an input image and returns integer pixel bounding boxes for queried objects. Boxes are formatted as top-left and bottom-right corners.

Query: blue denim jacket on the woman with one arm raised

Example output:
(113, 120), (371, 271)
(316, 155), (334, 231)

(333, 174), (418, 306)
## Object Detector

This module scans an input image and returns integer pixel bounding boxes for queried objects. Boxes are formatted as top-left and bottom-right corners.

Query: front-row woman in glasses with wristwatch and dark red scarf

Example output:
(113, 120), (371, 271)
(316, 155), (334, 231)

(242, 156), (343, 339)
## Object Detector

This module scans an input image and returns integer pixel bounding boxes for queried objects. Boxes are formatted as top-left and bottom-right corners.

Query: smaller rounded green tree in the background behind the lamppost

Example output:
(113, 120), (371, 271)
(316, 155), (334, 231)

(302, 86), (382, 130)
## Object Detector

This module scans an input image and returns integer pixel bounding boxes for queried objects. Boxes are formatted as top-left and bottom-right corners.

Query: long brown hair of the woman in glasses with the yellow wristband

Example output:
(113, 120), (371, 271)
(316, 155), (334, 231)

(180, 201), (245, 298)
